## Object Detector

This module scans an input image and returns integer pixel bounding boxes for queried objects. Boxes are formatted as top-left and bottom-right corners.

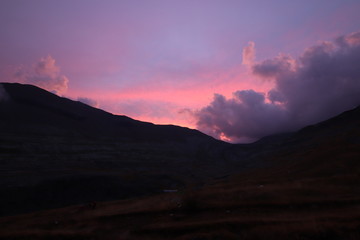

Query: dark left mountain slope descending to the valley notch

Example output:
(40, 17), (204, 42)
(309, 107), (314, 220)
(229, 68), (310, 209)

(0, 83), (228, 215)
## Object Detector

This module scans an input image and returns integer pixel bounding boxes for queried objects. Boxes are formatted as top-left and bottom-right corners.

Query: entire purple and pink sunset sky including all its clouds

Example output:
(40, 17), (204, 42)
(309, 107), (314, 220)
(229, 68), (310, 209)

(0, 0), (360, 142)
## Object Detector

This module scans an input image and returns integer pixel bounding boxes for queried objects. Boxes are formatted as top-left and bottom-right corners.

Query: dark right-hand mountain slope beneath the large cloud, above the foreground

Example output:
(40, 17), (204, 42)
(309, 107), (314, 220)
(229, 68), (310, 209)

(236, 104), (360, 178)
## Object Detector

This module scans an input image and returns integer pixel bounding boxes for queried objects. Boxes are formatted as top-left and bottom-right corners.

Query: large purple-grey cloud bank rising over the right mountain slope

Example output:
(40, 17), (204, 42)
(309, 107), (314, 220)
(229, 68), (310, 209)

(195, 32), (360, 142)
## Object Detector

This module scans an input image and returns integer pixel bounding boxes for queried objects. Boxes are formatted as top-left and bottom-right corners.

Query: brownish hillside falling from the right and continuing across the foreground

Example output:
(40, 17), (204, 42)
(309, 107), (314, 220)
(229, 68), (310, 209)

(0, 93), (360, 240)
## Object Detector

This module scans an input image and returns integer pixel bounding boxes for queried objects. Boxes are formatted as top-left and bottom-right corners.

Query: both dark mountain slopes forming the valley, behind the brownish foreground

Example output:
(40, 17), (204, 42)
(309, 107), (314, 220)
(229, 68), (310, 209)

(0, 83), (360, 218)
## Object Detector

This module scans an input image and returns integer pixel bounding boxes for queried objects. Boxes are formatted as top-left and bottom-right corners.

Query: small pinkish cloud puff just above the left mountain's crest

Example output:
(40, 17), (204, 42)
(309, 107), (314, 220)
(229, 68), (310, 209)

(13, 56), (69, 95)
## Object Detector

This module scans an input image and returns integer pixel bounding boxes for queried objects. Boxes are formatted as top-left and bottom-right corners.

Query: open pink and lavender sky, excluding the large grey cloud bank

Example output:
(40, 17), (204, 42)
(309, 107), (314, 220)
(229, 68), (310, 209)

(0, 0), (360, 142)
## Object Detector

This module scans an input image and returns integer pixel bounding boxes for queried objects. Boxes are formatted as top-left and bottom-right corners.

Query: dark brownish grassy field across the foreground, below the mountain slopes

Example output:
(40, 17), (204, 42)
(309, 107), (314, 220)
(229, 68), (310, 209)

(0, 172), (360, 240)
